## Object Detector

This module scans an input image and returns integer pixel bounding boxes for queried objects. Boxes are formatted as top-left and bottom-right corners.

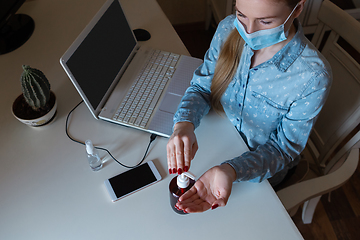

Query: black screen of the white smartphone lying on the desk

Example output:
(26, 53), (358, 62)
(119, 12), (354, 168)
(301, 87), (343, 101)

(104, 162), (159, 200)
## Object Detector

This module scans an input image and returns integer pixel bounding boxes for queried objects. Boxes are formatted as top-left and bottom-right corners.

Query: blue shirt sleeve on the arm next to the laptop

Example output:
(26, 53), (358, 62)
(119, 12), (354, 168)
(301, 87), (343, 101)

(174, 19), (231, 128)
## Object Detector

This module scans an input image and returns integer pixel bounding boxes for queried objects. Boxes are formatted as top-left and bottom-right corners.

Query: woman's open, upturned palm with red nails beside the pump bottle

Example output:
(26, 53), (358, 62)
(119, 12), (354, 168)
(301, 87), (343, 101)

(176, 164), (236, 213)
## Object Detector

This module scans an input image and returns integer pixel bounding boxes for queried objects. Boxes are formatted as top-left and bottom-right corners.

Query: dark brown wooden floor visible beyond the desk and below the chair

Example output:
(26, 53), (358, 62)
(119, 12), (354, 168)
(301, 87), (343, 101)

(174, 23), (360, 240)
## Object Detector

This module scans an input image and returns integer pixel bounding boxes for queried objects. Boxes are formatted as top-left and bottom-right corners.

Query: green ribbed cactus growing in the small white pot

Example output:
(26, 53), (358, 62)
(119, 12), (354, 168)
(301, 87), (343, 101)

(20, 65), (50, 111)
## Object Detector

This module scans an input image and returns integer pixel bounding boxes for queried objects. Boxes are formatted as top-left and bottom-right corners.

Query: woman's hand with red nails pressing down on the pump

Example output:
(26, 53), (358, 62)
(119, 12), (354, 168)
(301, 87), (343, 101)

(166, 122), (198, 174)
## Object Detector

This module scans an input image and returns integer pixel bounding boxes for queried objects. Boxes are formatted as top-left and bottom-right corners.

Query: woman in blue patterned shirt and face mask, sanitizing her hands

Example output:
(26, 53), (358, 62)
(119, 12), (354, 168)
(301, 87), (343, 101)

(167, 0), (332, 212)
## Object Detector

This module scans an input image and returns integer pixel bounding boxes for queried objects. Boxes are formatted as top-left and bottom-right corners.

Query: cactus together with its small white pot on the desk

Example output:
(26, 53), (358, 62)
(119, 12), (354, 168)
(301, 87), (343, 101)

(12, 65), (57, 127)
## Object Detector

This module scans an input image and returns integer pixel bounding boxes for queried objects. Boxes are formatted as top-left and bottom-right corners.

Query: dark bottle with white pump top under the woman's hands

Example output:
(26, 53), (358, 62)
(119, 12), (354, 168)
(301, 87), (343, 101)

(169, 172), (195, 214)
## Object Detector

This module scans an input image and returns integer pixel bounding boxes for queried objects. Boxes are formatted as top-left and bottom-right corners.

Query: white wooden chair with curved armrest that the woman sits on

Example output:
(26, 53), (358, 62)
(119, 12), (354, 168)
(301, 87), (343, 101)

(277, 0), (360, 223)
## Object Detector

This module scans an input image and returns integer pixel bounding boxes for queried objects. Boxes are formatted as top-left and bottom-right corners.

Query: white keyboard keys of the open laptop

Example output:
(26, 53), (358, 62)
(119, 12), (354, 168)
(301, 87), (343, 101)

(113, 49), (180, 128)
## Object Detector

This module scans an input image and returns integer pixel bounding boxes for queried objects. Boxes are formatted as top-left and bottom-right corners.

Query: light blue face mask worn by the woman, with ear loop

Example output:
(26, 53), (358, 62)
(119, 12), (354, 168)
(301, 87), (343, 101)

(234, 4), (298, 50)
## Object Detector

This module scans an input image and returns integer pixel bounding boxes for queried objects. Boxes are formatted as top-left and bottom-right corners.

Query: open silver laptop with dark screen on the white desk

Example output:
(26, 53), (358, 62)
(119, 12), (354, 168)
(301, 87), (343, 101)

(60, 0), (202, 137)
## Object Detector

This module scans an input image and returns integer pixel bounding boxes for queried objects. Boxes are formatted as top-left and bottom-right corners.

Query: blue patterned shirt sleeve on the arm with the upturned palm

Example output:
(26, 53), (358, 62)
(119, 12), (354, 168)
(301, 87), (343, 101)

(224, 71), (332, 182)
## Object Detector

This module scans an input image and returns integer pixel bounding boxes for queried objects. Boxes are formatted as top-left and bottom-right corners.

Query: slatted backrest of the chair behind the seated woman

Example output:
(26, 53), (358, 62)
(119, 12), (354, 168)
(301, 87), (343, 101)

(308, 0), (360, 166)
